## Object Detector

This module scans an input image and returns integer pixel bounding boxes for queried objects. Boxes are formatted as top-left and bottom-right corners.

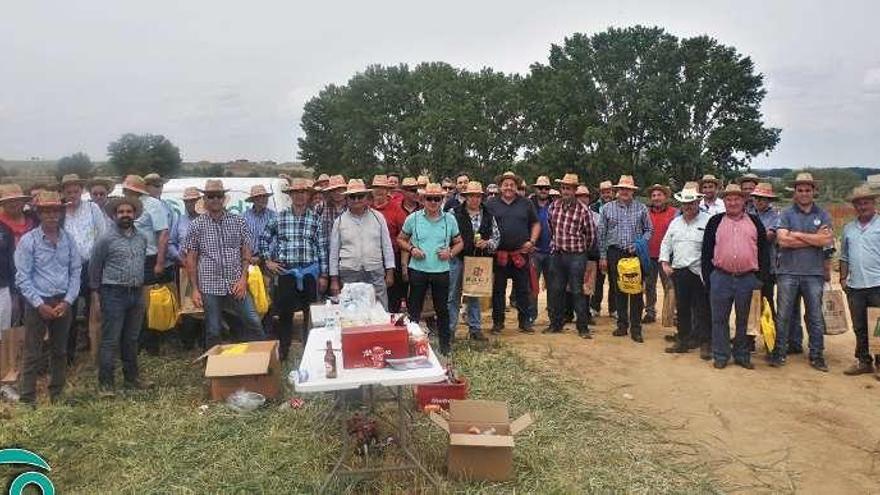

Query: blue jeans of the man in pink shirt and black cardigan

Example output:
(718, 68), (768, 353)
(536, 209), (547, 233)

(709, 270), (758, 363)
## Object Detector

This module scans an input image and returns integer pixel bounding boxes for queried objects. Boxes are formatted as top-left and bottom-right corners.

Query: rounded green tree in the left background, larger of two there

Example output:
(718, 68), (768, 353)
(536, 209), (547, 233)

(107, 134), (182, 177)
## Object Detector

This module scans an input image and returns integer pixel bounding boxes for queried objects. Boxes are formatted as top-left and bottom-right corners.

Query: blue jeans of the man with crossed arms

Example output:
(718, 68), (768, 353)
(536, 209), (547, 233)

(773, 275), (825, 359)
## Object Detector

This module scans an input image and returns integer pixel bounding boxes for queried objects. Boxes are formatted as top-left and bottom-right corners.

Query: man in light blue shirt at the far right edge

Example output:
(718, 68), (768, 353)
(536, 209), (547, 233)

(840, 186), (880, 380)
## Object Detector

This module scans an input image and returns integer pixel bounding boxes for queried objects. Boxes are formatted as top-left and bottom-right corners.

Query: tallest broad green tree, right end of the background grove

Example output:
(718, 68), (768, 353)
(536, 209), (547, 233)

(521, 26), (780, 188)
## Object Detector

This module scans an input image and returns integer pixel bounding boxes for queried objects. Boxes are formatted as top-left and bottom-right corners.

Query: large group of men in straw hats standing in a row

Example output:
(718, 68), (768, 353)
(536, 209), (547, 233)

(0, 167), (880, 404)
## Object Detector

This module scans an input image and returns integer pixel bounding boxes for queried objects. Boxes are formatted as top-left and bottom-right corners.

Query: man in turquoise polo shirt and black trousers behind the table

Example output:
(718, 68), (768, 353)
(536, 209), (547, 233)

(397, 183), (464, 356)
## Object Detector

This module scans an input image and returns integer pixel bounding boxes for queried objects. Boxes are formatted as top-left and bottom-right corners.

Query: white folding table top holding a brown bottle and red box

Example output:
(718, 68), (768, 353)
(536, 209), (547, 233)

(294, 327), (446, 393)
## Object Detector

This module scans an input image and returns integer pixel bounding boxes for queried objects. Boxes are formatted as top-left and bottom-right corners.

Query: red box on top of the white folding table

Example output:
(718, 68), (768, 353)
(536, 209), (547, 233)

(342, 323), (409, 369)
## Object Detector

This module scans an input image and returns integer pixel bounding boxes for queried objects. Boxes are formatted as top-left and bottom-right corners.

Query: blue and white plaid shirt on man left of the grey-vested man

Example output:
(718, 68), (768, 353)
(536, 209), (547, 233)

(259, 208), (330, 275)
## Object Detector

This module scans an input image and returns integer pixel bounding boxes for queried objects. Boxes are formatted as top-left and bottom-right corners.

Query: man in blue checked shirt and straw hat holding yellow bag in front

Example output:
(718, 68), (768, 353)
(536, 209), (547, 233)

(599, 175), (654, 343)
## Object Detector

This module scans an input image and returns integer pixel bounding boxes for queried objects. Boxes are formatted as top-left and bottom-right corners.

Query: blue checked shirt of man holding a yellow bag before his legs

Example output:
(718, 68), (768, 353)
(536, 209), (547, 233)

(599, 200), (654, 259)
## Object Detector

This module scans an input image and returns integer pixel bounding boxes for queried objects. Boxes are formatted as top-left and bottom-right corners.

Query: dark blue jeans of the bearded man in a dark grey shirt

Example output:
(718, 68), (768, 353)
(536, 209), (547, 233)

(99, 285), (145, 388)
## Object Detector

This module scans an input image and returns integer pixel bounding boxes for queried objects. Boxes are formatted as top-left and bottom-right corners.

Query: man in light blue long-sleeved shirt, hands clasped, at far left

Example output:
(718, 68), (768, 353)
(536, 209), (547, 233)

(15, 191), (82, 406)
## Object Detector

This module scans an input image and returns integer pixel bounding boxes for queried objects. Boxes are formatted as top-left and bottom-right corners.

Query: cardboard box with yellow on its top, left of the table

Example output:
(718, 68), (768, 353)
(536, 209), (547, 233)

(196, 340), (281, 401)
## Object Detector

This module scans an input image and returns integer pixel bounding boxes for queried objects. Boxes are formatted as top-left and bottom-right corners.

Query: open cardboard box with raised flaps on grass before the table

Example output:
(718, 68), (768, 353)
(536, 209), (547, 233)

(431, 400), (533, 481)
